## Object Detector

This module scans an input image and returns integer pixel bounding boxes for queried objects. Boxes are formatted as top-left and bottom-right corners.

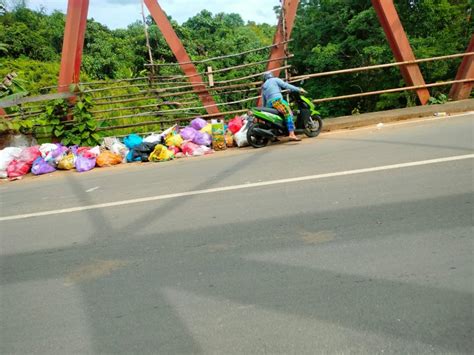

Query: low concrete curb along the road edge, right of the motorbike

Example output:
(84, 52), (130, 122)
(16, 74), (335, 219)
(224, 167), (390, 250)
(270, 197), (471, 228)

(323, 99), (474, 132)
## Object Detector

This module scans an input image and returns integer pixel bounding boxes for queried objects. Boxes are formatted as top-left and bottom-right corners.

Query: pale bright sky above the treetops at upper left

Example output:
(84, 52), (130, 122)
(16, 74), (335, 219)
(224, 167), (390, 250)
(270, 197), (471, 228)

(27, 0), (280, 29)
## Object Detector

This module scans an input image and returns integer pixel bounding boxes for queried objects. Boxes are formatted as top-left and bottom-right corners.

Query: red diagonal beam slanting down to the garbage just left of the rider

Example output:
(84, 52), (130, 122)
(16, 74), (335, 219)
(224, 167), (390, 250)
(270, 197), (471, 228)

(144, 0), (219, 114)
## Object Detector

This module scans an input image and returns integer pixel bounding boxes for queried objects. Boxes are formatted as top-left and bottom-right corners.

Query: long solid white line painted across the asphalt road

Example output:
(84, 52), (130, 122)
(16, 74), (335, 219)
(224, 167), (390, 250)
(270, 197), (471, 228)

(0, 154), (474, 222)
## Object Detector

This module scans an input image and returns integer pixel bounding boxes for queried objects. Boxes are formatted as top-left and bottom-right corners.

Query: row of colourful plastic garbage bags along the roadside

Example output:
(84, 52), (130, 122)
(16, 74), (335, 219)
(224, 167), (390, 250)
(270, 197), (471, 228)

(0, 116), (249, 180)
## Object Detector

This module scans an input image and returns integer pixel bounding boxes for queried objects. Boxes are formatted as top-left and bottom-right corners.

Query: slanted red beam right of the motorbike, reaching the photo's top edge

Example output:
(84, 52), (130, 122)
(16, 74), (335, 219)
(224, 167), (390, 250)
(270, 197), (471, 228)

(371, 0), (430, 105)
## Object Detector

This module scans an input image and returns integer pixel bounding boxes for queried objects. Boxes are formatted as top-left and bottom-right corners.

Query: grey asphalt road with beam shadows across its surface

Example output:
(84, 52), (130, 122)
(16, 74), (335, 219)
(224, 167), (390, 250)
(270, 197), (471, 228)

(0, 115), (474, 354)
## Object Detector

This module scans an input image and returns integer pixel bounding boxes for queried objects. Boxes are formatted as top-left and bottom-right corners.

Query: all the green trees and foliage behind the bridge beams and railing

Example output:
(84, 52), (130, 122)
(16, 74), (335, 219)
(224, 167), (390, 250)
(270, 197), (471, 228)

(0, 0), (474, 126)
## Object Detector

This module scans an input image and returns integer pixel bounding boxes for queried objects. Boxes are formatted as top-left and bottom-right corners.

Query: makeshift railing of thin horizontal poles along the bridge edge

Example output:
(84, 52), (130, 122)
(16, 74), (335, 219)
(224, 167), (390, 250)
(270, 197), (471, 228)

(0, 50), (474, 142)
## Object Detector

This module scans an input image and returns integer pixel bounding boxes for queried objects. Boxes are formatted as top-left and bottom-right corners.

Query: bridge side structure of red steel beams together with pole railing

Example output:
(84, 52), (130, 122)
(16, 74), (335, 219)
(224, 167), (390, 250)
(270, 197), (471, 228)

(0, 0), (474, 136)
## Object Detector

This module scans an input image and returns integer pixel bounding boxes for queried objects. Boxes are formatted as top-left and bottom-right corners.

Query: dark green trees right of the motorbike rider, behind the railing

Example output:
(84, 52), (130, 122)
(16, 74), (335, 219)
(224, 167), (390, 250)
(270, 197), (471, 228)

(290, 0), (474, 116)
